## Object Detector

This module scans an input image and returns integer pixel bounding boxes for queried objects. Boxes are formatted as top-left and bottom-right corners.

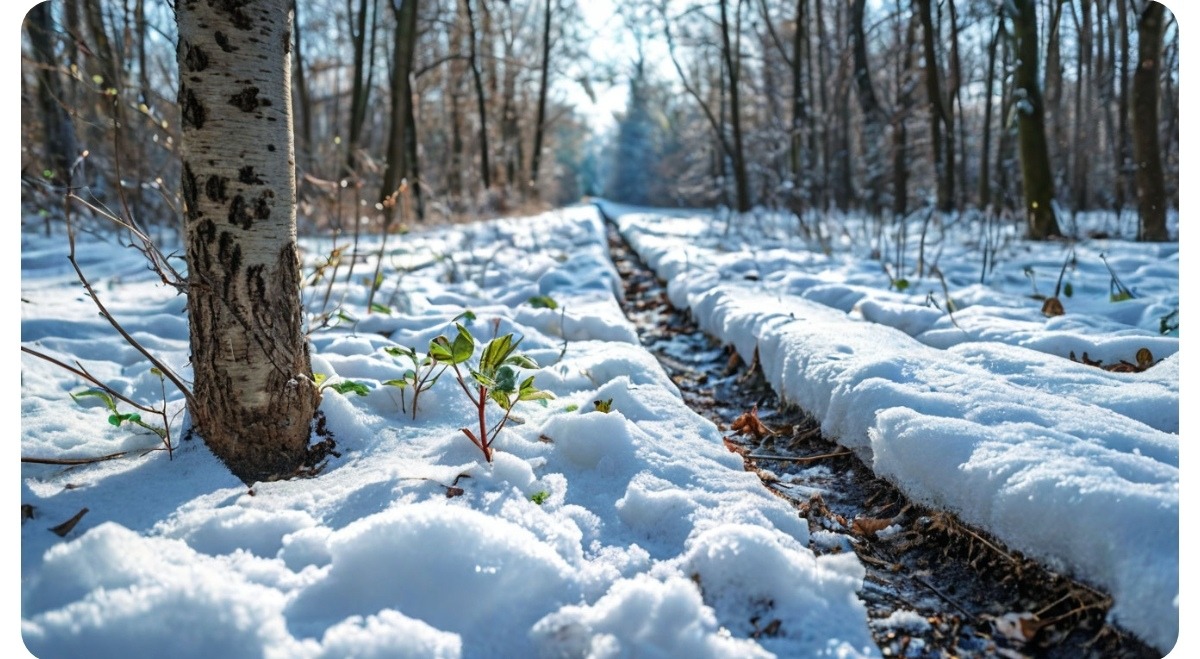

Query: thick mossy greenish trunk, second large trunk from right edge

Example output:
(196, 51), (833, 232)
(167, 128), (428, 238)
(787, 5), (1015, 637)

(1012, 0), (1062, 240)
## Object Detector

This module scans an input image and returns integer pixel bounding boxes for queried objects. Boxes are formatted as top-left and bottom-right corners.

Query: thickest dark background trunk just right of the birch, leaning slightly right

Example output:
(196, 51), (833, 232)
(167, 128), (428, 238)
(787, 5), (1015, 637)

(379, 0), (418, 223)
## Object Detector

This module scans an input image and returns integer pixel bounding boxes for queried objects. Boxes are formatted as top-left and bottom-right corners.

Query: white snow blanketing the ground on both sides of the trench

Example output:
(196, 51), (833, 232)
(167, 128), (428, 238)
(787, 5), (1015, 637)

(20, 205), (1180, 658)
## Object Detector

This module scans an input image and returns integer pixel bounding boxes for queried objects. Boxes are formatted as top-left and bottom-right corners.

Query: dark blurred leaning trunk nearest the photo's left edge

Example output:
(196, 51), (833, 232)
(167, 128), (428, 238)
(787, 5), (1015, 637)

(22, 2), (79, 187)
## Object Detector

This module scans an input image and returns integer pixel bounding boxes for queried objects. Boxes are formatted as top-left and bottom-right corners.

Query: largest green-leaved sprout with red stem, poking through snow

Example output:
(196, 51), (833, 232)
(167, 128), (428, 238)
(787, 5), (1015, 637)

(430, 323), (554, 462)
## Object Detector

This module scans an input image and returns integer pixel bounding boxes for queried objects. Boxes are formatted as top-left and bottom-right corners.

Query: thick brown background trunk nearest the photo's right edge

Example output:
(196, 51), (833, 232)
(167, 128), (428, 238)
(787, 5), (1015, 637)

(1129, 2), (1170, 241)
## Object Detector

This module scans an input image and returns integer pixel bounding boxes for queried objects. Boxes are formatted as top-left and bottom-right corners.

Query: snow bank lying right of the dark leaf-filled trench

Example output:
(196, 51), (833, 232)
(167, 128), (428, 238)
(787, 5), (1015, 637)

(610, 201), (1178, 649)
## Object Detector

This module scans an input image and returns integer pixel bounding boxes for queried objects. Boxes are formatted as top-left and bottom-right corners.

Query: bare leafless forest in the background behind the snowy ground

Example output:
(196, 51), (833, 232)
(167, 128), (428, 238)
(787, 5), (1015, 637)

(22, 0), (1180, 240)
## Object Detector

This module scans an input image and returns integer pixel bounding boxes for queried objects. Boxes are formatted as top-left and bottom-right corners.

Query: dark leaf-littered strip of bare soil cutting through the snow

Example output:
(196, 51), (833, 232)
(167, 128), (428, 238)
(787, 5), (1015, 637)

(608, 226), (1162, 659)
